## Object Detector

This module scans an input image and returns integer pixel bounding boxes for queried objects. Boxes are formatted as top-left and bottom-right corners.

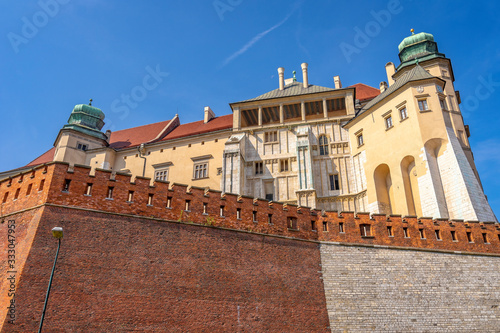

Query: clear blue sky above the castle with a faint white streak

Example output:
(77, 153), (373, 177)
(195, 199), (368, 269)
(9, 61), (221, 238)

(0, 0), (500, 214)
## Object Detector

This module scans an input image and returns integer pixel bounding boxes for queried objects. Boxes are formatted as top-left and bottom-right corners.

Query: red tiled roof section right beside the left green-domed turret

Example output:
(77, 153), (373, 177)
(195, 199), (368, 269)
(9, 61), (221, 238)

(109, 120), (174, 149)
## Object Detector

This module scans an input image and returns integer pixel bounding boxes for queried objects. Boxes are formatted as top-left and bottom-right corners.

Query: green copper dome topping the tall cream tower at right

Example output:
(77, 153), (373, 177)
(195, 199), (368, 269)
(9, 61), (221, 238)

(397, 29), (445, 70)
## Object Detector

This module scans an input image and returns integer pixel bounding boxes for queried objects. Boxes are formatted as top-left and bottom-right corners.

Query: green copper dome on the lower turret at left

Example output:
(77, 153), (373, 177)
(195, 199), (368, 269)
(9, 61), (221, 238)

(63, 104), (106, 139)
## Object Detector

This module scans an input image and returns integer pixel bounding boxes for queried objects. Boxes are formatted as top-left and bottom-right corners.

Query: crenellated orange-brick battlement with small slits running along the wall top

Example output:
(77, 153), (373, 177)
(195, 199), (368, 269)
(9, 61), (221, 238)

(0, 162), (500, 253)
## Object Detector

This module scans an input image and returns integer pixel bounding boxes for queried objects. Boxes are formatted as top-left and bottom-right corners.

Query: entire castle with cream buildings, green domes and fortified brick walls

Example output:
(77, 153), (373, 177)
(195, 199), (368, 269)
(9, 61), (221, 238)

(0, 33), (500, 332)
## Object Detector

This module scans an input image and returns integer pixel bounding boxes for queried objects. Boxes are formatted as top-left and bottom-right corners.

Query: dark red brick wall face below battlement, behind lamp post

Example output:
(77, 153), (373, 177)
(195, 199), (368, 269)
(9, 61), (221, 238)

(2, 207), (328, 332)
